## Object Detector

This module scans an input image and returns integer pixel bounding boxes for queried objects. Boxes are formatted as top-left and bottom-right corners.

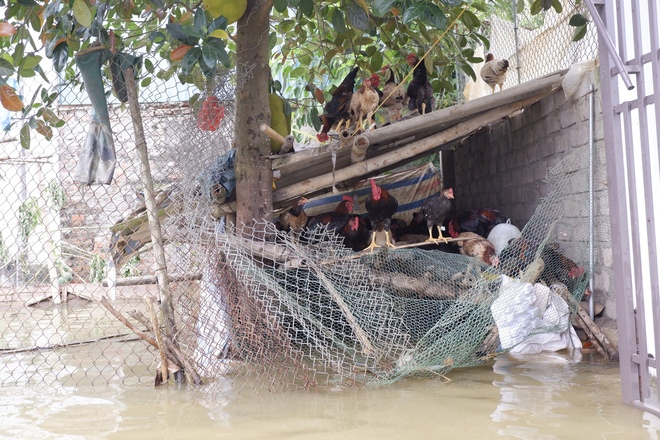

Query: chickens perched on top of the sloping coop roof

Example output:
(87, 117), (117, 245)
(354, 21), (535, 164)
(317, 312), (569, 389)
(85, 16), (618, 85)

(316, 53), (509, 142)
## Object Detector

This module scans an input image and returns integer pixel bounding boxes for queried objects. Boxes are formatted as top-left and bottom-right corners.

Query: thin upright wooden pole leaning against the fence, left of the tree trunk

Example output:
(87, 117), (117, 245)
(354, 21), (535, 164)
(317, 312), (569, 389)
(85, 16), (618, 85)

(124, 67), (176, 338)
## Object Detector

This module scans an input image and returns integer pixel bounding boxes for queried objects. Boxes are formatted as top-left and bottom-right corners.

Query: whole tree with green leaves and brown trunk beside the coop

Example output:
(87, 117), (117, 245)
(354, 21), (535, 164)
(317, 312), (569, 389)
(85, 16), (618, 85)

(0, 0), (584, 223)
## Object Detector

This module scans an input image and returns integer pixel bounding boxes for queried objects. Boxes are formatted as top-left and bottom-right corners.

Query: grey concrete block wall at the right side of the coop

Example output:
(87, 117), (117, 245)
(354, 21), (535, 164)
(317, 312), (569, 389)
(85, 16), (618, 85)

(452, 78), (616, 334)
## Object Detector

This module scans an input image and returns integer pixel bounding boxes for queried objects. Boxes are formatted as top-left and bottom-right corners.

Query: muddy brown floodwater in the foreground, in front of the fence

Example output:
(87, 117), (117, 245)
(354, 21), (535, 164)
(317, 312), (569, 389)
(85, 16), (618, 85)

(0, 353), (660, 440)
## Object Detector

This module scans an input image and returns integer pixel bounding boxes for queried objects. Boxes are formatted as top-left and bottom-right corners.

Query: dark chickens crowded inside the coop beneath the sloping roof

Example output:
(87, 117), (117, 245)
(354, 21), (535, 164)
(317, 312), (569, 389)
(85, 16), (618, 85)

(276, 179), (585, 292)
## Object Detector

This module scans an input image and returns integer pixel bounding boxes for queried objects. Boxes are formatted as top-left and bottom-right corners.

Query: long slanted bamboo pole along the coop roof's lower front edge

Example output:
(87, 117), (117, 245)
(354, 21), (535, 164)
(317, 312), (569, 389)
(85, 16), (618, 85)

(273, 96), (552, 203)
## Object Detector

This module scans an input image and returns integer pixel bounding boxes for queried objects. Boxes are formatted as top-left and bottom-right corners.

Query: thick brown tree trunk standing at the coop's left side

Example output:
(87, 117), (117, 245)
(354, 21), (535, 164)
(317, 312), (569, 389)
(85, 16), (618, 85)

(234, 0), (273, 234)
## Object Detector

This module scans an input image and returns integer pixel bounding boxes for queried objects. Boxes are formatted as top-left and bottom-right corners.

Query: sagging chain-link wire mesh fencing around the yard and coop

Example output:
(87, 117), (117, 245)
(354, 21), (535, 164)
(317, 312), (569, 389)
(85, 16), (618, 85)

(0, 0), (595, 395)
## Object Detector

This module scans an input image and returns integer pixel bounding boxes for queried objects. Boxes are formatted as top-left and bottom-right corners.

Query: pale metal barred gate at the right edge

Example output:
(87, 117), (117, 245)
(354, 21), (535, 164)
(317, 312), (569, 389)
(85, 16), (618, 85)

(586, 0), (660, 415)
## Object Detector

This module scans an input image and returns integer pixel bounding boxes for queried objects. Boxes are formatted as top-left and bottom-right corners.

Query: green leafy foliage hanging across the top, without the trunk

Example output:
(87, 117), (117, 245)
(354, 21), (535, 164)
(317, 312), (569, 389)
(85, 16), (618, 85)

(0, 0), (496, 140)
